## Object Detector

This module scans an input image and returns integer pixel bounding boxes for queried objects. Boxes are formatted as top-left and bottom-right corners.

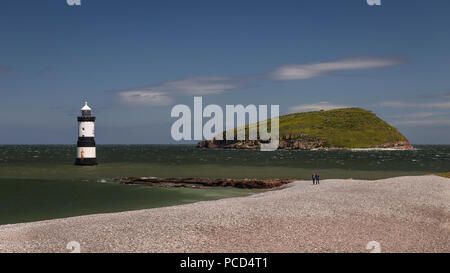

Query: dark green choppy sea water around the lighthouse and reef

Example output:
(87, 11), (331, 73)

(0, 145), (450, 224)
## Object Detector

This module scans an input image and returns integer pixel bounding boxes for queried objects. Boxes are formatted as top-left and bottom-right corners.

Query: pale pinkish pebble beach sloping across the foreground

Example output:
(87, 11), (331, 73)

(0, 175), (450, 253)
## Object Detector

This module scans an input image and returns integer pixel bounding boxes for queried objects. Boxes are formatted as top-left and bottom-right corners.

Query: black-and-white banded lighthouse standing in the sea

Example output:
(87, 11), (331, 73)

(75, 102), (97, 166)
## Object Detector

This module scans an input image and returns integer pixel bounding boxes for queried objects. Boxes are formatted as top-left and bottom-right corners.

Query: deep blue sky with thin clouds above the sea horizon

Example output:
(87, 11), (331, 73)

(0, 0), (450, 144)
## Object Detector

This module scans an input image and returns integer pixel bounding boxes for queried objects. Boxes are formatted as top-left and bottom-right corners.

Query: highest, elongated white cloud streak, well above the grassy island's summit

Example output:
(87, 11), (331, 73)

(270, 57), (405, 80)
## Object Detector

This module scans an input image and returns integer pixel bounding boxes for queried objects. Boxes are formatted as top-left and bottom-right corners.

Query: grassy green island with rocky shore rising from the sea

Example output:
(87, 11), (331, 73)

(198, 108), (412, 150)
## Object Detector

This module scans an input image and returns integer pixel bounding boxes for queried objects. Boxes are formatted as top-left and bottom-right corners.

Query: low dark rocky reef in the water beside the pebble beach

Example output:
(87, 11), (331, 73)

(116, 177), (294, 189)
